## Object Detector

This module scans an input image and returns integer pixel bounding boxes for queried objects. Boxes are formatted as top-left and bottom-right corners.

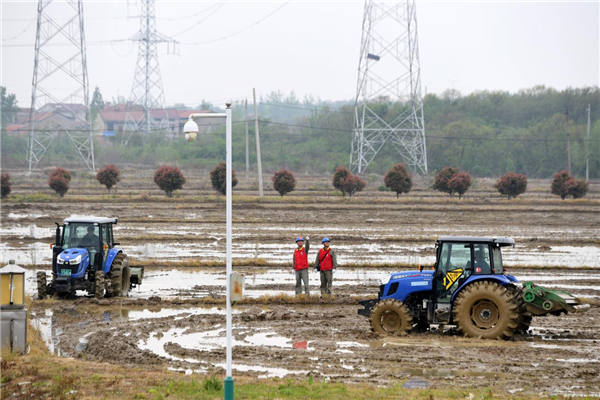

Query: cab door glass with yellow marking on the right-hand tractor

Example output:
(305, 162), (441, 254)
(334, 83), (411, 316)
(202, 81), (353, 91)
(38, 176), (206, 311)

(436, 243), (472, 303)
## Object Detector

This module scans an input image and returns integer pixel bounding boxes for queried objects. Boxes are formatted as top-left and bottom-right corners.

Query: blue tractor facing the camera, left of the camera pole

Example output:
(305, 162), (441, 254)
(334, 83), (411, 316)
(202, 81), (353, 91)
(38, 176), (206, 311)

(37, 217), (144, 299)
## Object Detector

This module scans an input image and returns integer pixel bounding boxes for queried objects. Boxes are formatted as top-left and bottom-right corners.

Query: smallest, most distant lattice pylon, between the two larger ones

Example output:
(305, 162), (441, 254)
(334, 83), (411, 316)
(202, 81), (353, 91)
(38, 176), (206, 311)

(125, 0), (178, 132)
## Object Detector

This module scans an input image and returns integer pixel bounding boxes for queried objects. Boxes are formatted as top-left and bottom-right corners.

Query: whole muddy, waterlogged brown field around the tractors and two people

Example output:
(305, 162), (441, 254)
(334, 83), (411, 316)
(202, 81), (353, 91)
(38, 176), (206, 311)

(0, 171), (600, 396)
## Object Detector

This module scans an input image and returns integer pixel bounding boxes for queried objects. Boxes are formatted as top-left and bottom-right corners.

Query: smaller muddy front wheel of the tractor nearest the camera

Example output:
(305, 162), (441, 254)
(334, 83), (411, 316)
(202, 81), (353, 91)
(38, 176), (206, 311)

(370, 299), (413, 336)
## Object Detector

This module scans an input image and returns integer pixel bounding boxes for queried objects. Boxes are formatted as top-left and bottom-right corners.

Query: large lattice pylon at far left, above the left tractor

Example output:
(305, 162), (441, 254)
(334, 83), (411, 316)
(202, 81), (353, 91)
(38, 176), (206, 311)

(27, 0), (95, 172)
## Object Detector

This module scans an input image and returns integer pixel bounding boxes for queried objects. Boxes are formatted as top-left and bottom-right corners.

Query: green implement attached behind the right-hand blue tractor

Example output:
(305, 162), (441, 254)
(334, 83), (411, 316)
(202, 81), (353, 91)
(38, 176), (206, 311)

(523, 282), (589, 315)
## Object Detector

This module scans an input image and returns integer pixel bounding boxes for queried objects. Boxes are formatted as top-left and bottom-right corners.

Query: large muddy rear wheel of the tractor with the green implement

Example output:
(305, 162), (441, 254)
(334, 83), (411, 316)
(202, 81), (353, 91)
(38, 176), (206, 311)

(453, 281), (519, 339)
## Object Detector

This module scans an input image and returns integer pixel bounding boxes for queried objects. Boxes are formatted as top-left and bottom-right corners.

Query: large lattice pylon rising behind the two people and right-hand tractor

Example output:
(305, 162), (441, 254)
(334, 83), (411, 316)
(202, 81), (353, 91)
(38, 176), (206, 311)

(350, 0), (427, 173)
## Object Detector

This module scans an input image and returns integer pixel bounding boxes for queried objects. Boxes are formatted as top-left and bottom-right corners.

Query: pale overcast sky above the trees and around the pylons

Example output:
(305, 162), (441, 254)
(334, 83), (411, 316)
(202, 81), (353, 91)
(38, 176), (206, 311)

(0, 0), (600, 107)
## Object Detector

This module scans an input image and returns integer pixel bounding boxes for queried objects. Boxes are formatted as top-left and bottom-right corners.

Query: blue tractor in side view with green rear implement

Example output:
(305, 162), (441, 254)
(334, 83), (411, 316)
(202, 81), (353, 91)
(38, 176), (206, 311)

(358, 236), (588, 339)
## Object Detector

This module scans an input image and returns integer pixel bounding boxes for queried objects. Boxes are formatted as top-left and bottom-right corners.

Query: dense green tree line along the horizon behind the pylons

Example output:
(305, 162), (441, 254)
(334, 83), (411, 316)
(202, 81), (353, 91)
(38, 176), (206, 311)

(2, 86), (600, 179)
